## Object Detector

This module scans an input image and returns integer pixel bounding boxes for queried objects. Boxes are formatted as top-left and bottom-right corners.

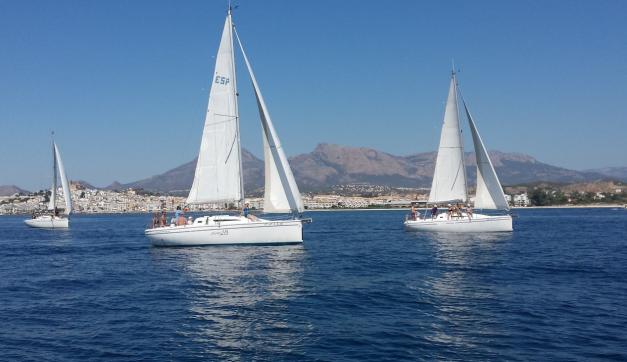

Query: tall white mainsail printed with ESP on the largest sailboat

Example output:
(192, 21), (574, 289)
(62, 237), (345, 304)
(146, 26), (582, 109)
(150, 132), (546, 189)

(187, 12), (244, 204)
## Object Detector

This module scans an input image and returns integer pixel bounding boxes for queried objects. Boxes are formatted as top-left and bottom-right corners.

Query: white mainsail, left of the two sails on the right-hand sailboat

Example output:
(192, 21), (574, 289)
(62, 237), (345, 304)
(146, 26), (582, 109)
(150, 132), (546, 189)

(429, 73), (468, 203)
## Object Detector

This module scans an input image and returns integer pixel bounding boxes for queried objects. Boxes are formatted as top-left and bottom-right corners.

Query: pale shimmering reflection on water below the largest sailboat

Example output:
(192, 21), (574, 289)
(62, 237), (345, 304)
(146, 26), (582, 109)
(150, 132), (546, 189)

(152, 245), (305, 358)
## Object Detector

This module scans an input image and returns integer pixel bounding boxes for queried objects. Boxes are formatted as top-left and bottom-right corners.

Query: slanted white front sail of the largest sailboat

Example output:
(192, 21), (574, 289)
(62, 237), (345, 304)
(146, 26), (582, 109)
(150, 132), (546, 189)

(235, 31), (305, 213)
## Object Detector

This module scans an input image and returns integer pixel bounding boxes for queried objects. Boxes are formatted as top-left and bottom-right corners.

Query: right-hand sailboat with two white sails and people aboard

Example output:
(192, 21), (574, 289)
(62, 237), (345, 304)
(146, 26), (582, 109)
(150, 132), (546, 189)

(405, 71), (513, 232)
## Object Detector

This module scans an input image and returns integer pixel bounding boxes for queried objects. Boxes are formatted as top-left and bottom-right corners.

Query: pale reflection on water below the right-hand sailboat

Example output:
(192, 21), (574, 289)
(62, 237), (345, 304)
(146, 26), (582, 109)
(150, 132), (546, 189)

(422, 233), (512, 348)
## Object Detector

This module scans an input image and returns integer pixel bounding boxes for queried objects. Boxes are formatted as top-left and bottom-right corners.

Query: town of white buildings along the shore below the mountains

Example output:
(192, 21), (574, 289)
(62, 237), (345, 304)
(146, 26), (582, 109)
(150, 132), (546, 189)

(0, 182), (627, 215)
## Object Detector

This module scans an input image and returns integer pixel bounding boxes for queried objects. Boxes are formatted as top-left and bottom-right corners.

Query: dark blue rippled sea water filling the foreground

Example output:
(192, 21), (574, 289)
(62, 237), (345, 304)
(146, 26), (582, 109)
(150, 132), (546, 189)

(0, 209), (627, 361)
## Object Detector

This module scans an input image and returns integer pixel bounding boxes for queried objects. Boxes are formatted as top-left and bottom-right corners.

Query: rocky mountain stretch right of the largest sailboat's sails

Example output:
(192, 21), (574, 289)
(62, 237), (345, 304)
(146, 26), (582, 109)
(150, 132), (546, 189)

(290, 144), (604, 189)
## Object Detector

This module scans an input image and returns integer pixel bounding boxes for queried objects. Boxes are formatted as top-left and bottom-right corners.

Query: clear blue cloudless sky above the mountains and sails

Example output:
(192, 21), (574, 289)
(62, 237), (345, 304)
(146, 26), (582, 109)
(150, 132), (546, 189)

(0, 0), (627, 190)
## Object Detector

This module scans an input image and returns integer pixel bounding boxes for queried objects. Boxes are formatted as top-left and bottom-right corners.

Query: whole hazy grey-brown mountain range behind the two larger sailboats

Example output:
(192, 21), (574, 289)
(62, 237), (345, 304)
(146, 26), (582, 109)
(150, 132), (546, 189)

(108, 143), (607, 195)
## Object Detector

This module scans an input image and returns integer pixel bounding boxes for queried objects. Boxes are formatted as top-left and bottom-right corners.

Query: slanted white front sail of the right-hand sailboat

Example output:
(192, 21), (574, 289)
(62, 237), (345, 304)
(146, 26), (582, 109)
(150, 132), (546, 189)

(464, 102), (509, 210)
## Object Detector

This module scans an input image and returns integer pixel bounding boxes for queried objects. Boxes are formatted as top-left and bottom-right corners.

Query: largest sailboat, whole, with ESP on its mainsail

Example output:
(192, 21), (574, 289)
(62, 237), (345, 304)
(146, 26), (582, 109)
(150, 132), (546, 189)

(145, 6), (310, 246)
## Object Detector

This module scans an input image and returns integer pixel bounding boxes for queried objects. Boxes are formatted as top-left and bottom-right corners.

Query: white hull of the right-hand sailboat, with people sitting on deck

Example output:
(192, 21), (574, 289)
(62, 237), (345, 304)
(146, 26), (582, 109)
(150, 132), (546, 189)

(405, 214), (513, 233)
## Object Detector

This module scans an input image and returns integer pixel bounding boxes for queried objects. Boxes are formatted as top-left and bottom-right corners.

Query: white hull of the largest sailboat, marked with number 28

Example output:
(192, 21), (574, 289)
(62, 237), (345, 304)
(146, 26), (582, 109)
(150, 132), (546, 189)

(146, 215), (303, 246)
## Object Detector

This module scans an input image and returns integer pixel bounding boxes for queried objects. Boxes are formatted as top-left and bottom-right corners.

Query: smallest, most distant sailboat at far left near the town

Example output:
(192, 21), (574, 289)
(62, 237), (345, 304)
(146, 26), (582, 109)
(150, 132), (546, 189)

(24, 137), (72, 229)
